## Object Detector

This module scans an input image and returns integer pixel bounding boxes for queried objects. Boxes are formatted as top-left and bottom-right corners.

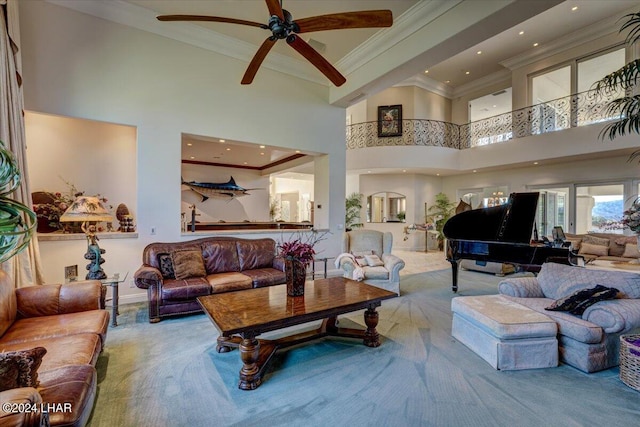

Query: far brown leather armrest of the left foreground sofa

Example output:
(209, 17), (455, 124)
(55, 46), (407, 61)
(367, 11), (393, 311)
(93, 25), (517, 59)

(16, 280), (102, 318)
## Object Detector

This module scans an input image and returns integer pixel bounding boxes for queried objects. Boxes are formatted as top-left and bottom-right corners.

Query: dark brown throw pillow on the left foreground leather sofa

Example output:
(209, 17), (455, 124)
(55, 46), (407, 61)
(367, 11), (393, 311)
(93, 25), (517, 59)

(0, 347), (47, 391)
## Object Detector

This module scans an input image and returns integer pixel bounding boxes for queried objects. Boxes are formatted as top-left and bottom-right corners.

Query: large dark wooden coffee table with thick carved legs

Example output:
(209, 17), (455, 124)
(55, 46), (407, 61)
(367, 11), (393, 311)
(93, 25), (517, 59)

(198, 277), (397, 390)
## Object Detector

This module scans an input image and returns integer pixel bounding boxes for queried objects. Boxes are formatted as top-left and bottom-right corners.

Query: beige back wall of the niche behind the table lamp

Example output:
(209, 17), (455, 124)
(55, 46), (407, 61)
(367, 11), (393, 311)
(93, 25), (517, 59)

(24, 111), (137, 240)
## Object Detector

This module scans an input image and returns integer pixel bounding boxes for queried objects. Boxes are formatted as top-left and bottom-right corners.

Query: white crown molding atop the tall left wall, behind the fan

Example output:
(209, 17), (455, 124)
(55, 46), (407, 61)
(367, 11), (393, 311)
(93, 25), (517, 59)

(45, 0), (329, 86)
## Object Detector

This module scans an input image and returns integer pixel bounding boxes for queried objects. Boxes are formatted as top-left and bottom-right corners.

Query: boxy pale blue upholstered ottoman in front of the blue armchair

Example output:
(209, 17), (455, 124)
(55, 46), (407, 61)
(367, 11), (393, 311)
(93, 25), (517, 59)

(451, 295), (558, 370)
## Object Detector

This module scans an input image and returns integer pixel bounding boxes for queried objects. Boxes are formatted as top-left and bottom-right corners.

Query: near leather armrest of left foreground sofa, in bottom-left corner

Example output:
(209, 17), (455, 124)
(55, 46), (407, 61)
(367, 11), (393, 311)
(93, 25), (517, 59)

(0, 387), (49, 427)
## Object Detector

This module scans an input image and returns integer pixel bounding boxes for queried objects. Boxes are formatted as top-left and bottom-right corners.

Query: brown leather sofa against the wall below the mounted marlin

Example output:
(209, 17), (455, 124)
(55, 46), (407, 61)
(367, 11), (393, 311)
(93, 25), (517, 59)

(134, 237), (286, 323)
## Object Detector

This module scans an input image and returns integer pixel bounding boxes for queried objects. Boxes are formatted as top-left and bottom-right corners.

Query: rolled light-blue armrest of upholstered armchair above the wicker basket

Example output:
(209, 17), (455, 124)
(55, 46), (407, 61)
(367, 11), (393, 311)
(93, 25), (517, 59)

(582, 298), (640, 333)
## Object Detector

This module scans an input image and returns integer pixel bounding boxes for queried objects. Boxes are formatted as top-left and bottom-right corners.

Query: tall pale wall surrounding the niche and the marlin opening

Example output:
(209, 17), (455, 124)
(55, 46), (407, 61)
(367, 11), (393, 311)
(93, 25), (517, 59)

(19, 0), (345, 301)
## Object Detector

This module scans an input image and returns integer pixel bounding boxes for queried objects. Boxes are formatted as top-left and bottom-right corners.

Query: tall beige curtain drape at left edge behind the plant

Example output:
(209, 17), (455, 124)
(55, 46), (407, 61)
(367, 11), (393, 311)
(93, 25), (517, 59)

(0, 0), (44, 287)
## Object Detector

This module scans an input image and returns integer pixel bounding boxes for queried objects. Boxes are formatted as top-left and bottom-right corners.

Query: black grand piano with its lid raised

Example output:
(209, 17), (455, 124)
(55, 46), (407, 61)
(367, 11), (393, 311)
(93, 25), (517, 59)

(442, 192), (572, 292)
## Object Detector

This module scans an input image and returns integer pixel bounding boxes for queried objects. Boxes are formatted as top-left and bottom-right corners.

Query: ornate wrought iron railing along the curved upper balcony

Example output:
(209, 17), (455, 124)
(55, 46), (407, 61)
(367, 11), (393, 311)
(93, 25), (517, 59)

(347, 91), (620, 149)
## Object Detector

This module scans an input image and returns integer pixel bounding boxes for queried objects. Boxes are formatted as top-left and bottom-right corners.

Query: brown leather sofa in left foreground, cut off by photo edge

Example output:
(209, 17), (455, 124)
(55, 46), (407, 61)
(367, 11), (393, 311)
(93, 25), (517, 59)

(0, 270), (109, 426)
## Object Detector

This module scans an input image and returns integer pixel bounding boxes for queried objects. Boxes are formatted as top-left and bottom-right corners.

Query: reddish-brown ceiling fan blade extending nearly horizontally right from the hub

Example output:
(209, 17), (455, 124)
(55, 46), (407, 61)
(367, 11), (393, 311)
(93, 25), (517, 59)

(296, 10), (393, 33)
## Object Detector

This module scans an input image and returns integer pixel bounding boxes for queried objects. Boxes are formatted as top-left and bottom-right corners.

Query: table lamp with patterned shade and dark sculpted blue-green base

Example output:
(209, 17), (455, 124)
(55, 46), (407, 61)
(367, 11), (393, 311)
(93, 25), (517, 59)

(60, 196), (113, 280)
